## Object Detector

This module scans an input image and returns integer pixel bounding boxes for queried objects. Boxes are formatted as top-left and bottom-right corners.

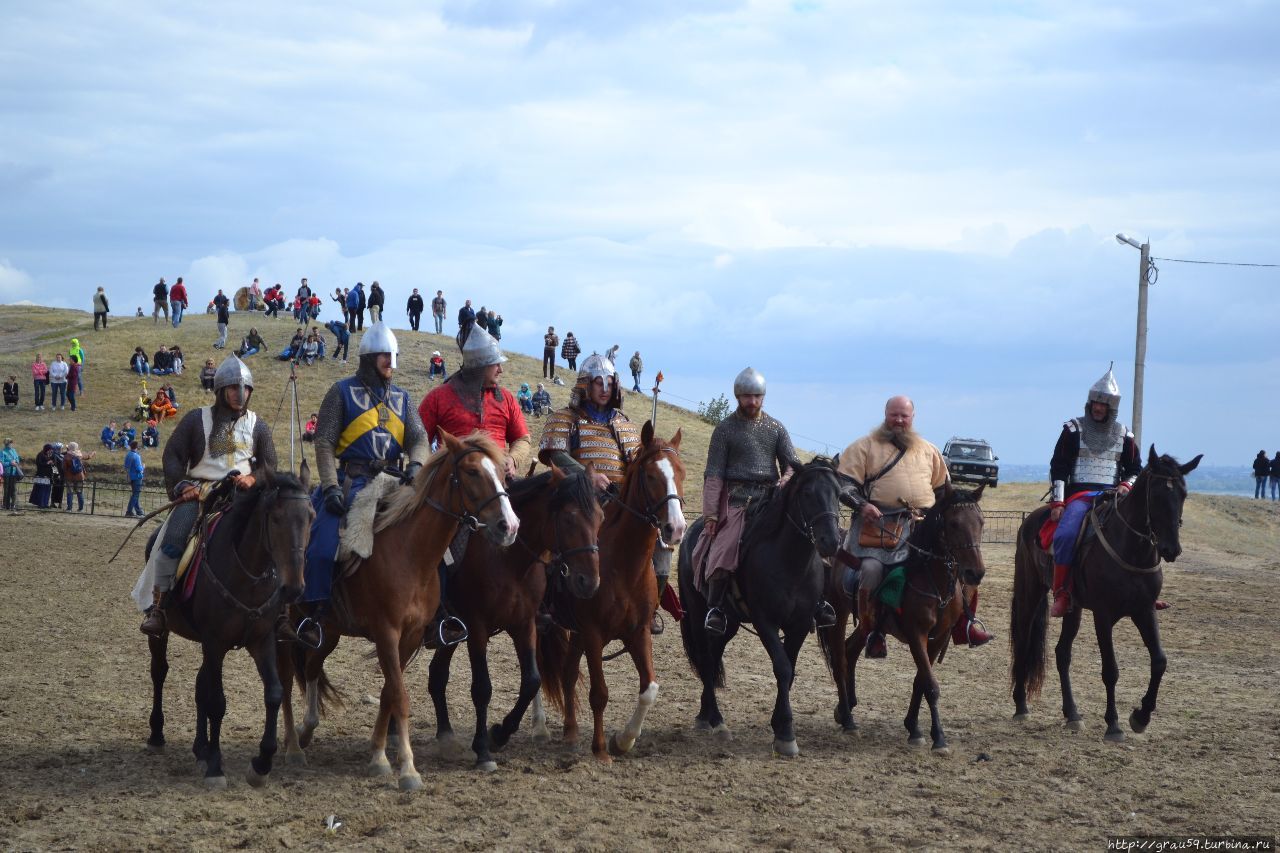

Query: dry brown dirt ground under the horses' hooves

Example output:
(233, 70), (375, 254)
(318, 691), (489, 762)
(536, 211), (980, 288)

(0, 488), (1280, 850)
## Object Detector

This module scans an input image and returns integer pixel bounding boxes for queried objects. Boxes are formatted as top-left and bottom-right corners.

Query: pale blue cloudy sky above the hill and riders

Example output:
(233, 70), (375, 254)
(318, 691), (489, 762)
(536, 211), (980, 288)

(0, 0), (1280, 465)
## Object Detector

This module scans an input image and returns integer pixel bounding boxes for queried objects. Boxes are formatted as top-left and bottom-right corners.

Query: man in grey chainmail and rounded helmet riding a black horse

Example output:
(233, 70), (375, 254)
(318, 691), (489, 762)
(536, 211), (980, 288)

(694, 368), (836, 634)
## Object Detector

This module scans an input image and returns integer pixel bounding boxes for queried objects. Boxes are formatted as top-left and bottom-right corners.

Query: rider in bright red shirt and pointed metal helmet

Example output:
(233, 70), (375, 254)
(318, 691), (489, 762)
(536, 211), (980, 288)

(417, 325), (531, 646)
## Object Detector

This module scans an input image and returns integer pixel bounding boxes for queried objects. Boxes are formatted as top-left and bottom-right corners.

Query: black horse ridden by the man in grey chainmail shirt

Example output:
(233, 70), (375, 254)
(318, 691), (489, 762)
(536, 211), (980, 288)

(680, 457), (844, 758)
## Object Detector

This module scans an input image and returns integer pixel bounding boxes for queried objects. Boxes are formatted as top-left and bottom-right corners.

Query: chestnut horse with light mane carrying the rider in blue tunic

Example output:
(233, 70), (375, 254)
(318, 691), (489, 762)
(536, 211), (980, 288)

(282, 430), (520, 790)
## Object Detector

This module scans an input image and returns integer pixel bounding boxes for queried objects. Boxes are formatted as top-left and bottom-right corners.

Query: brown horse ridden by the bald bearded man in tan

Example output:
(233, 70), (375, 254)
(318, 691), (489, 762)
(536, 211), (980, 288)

(818, 483), (987, 756)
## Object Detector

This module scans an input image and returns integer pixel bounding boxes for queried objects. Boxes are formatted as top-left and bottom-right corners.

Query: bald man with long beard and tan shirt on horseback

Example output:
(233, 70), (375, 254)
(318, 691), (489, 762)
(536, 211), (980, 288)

(838, 396), (992, 657)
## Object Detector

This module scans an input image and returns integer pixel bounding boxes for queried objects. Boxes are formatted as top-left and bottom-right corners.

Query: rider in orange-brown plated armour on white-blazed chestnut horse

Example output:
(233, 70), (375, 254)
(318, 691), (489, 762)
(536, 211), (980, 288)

(538, 352), (671, 634)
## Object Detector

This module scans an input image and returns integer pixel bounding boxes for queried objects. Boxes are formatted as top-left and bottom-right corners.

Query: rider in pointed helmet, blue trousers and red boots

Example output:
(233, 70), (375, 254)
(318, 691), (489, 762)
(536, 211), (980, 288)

(1048, 368), (1142, 619)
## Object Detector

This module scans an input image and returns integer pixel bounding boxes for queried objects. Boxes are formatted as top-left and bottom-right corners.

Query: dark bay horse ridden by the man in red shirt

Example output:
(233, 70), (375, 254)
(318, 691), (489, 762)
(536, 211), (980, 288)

(428, 467), (604, 772)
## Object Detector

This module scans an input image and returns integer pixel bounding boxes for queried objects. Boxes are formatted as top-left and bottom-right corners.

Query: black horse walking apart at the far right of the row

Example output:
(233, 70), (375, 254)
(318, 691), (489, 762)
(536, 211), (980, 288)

(1009, 444), (1203, 742)
